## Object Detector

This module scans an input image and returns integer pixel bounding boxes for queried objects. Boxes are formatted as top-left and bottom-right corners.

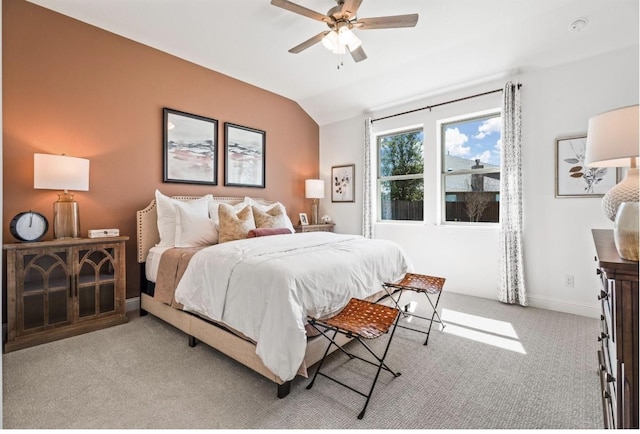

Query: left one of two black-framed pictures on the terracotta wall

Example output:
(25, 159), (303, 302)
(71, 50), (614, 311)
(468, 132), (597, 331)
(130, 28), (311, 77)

(162, 107), (218, 185)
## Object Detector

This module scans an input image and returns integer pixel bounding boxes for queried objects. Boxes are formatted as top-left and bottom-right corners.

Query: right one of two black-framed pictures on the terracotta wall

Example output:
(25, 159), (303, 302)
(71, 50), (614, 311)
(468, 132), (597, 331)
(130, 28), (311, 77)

(224, 122), (266, 188)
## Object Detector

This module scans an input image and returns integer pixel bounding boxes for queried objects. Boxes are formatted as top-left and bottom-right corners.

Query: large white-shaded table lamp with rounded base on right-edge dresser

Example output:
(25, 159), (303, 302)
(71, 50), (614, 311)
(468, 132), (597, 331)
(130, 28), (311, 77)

(585, 105), (640, 261)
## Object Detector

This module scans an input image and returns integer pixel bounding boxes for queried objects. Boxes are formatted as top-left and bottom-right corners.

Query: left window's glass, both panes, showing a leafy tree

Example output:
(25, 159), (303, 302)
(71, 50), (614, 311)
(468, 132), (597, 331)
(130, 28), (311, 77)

(377, 129), (424, 221)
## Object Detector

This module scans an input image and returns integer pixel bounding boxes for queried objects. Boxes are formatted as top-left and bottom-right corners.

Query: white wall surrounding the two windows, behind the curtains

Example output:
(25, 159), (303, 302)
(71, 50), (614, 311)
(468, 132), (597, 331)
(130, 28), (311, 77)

(320, 46), (639, 317)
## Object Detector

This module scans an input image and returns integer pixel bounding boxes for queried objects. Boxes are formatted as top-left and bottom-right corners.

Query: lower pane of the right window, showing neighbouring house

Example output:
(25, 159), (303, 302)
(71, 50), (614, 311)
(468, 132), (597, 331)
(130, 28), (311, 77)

(444, 172), (500, 223)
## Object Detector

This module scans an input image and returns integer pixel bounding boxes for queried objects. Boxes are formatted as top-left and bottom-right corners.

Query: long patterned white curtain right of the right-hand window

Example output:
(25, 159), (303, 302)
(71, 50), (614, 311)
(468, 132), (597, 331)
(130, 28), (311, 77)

(498, 82), (527, 306)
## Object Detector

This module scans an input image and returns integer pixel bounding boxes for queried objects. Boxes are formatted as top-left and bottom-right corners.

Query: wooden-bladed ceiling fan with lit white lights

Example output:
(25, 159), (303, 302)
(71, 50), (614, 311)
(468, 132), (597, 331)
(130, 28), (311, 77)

(271, 0), (418, 62)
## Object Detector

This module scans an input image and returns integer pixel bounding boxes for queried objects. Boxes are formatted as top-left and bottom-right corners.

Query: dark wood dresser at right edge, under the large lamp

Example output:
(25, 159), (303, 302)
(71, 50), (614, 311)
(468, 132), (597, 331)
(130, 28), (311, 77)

(592, 229), (640, 429)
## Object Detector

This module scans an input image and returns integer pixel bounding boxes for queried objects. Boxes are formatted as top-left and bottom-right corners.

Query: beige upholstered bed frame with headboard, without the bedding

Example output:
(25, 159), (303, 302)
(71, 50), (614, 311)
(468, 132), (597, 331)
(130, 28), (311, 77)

(136, 196), (350, 398)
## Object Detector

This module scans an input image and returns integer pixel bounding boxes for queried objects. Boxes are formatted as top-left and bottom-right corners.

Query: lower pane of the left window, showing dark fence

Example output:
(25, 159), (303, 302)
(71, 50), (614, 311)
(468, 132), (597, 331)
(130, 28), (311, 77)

(380, 179), (424, 221)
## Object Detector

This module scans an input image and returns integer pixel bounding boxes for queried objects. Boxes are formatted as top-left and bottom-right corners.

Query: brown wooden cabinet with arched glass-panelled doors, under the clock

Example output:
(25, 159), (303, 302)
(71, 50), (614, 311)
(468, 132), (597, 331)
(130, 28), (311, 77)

(3, 236), (129, 352)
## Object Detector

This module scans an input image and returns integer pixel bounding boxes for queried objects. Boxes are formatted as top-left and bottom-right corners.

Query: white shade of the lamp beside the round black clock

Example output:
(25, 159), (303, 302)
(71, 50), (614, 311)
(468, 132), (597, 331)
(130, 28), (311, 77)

(33, 154), (89, 191)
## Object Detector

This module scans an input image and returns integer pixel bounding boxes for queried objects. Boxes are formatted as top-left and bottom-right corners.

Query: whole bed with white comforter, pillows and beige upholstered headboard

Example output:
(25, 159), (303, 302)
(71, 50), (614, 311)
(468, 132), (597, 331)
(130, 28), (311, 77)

(136, 192), (411, 398)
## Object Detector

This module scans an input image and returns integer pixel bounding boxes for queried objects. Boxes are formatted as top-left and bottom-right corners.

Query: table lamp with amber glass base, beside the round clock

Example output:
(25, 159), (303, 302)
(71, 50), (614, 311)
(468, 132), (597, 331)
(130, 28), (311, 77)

(33, 154), (89, 239)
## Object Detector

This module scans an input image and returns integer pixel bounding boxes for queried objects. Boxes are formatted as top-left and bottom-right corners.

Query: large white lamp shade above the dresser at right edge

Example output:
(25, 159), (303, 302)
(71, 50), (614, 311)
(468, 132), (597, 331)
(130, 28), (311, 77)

(584, 105), (640, 167)
